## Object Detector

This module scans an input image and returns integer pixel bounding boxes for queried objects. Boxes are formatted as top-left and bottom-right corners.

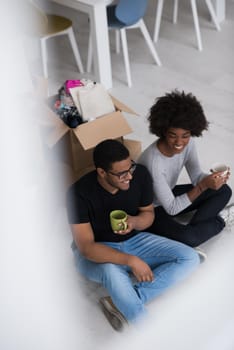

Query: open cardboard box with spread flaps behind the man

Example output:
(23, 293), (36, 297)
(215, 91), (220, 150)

(40, 92), (141, 179)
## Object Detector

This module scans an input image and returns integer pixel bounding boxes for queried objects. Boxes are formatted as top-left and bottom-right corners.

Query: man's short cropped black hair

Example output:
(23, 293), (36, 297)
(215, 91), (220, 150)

(93, 139), (129, 171)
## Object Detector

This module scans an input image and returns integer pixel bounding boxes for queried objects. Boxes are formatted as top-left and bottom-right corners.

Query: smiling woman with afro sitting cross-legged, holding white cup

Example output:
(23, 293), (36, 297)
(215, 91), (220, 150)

(139, 90), (234, 247)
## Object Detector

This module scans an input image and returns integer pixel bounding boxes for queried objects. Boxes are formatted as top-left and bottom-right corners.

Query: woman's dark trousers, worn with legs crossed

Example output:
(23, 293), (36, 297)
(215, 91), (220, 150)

(147, 184), (232, 247)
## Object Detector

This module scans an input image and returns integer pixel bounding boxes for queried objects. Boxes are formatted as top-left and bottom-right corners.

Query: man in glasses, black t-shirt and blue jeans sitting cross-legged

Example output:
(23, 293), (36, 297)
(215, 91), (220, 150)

(67, 140), (199, 331)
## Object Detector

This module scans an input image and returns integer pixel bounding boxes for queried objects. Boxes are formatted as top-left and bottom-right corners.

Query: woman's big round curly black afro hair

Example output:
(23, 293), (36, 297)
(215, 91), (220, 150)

(148, 90), (209, 138)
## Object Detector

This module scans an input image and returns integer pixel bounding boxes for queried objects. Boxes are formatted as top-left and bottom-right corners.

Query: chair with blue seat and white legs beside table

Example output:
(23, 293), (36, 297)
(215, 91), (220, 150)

(87, 0), (161, 87)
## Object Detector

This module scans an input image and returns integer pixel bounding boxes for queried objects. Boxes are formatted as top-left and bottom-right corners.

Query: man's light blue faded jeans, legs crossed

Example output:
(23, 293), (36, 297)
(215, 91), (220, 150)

(74, 232), (199, 322)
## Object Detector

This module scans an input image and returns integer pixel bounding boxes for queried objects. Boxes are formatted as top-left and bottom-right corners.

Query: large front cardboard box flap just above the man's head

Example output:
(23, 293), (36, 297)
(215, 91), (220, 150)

(73, 112), (132, 150)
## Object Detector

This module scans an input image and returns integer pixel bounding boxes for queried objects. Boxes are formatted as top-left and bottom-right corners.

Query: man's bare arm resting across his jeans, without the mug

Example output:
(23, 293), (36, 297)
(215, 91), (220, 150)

(71, 223), (154, 282)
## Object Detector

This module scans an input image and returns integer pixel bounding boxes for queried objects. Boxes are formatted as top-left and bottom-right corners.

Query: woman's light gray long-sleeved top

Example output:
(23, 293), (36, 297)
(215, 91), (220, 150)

(138, 138), (206, 215)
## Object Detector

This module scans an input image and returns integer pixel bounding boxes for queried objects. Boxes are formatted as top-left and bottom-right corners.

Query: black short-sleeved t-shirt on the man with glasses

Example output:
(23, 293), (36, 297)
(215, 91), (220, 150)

(67, 164), (153, 242)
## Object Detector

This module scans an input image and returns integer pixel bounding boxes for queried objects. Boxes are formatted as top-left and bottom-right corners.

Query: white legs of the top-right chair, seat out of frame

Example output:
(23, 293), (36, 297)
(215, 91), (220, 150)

(153, 0), (221, 51)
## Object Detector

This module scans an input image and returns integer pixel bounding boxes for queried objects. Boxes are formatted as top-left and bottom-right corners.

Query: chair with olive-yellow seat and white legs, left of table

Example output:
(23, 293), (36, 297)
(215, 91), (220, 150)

(31, 1), (84, 78)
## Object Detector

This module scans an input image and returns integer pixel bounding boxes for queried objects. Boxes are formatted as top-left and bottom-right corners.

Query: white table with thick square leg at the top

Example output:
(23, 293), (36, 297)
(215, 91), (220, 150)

(52, 0), (226, 89)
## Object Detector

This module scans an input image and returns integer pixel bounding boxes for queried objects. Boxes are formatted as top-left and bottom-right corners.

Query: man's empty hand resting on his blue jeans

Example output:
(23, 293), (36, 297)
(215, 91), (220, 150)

(128, 255), (155, 282)
